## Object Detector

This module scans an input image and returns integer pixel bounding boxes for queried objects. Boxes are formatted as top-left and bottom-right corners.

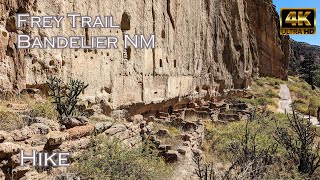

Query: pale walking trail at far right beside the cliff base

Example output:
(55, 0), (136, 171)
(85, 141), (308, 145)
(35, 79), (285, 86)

(278, 84), (320, 127)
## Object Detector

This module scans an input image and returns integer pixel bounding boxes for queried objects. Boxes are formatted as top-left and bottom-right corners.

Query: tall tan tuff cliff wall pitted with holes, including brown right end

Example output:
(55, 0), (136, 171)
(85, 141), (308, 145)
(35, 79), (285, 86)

(0, 0), (289, 108)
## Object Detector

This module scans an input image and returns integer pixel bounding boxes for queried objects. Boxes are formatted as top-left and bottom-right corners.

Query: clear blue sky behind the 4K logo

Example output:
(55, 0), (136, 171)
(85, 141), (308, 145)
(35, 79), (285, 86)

(273, 0), (320, 46)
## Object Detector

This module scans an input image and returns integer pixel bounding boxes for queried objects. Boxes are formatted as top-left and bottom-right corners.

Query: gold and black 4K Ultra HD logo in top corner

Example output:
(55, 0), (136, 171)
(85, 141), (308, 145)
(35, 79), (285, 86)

(280, 8), (316, 35)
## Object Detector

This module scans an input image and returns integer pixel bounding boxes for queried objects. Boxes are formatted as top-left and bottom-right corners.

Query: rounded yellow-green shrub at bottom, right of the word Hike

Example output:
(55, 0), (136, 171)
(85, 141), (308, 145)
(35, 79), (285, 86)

(77, 136), (171, 179)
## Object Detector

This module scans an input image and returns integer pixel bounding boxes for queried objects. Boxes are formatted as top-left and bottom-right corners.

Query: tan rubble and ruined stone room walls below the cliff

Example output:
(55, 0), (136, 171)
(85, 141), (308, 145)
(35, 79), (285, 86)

(0, 89), (249, 179)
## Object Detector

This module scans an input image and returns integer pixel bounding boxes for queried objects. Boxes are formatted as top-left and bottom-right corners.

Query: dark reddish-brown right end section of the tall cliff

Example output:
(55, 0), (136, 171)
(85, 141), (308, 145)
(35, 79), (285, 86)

(247, 0), (290, 79)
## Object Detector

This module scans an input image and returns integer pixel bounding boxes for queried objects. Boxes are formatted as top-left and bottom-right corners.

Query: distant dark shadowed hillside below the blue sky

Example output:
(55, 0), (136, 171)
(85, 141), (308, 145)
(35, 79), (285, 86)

(289, 39), (320, 75)
